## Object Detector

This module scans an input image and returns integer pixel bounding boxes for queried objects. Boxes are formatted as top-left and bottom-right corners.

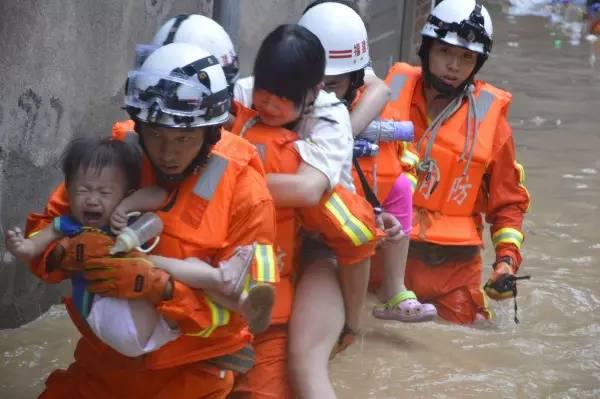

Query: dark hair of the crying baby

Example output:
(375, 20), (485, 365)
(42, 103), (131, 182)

(62, 137), (142, 191)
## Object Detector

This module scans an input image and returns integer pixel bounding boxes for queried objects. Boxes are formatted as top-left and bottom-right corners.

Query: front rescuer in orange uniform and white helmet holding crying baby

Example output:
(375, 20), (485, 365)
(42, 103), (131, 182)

(27, 43), (278, 398)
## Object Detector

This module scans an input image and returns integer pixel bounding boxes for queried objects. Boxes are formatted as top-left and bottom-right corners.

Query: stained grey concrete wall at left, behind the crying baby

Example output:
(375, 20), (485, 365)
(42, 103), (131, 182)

(0, 0), (212, 328)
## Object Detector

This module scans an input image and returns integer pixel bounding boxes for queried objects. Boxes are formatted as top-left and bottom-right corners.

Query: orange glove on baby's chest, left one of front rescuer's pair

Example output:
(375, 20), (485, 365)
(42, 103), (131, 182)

(48, 230), (115, 275)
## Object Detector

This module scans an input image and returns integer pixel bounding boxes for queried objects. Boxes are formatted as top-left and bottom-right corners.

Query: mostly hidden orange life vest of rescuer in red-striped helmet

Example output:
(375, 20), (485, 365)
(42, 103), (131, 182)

(352, 86), (408, 203)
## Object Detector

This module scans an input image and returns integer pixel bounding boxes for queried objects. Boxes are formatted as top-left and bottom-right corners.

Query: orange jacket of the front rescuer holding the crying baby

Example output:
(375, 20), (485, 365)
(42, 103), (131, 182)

(28, 121), (278, 369)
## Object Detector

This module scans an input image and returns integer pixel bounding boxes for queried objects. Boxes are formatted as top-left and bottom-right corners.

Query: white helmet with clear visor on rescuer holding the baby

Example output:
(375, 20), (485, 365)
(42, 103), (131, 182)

(125, 43), (229, 128)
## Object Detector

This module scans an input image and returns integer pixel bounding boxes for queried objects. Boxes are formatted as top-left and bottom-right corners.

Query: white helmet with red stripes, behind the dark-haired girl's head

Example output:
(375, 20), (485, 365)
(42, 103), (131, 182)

(298, 3), (370, 76)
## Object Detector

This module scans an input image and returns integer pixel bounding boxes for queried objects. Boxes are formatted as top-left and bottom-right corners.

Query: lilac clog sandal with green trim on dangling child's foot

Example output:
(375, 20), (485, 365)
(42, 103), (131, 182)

(373, 290), (437, 323)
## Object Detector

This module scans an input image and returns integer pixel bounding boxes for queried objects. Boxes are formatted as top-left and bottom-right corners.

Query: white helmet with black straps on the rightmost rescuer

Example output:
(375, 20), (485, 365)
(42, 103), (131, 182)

(421, 0), (493, 56)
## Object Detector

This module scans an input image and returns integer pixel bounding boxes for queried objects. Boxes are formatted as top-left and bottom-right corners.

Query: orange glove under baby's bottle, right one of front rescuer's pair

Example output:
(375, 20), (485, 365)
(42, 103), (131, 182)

(84, 251), (171, 304)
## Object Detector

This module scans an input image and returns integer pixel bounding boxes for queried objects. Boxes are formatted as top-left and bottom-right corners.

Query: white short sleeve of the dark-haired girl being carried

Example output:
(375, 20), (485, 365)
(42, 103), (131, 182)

(294, 105), (354, 190)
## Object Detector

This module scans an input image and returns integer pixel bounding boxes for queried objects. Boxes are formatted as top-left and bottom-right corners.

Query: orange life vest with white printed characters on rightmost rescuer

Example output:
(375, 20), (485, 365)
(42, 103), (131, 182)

(386, 63), (511, 245)
